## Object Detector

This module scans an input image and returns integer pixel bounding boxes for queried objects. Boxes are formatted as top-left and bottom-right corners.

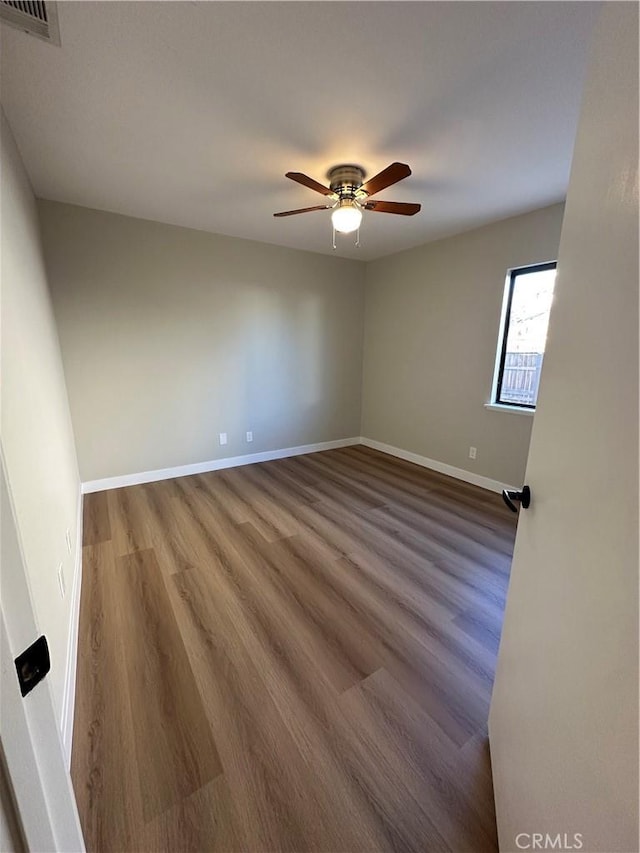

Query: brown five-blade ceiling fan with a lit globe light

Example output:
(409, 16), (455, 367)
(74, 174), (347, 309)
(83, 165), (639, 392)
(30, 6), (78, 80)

(273, 163), (421, 249)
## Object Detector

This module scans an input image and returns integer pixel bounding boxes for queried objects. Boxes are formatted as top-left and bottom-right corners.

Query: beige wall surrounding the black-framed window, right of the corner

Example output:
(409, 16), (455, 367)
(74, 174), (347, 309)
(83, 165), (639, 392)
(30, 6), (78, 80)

(362, 204), (563, 485)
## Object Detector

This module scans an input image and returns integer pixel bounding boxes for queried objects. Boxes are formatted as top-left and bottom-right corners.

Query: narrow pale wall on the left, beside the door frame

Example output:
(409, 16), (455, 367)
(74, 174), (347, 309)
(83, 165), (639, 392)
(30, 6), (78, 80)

(0, 113), (80, 723)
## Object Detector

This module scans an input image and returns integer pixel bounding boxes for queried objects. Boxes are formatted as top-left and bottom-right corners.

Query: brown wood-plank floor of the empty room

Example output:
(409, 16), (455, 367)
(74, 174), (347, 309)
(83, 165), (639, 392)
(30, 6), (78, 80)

(72, 446), (515, 853)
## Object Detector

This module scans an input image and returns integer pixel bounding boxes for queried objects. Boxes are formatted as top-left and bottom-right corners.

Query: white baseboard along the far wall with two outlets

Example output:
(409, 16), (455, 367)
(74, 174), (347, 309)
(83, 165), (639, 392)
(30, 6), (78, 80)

(82, 436), (361, 495)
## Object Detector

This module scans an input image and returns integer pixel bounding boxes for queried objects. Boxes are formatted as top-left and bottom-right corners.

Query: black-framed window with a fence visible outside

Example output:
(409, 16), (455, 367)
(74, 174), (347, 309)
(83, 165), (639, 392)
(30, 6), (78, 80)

(492, 262), (556, 410)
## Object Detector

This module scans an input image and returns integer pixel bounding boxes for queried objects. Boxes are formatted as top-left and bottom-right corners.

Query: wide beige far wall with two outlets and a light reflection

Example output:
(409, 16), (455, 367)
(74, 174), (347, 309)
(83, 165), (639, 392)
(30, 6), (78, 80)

(39, 202), (364, 481)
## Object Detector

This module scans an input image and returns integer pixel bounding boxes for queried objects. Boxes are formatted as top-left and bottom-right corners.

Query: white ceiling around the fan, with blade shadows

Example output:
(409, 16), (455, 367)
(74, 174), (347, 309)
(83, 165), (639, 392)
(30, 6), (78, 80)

(1, 2), (599, 260)
